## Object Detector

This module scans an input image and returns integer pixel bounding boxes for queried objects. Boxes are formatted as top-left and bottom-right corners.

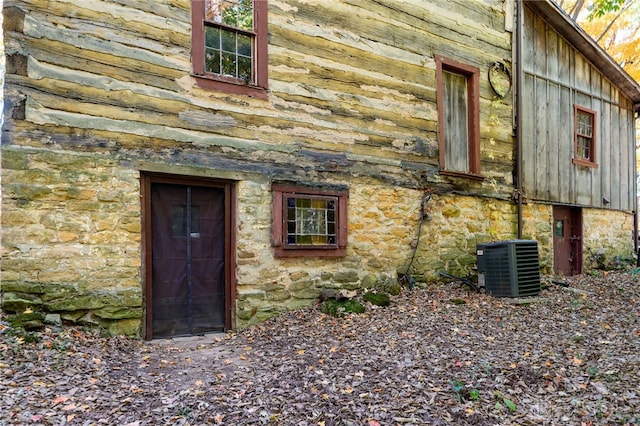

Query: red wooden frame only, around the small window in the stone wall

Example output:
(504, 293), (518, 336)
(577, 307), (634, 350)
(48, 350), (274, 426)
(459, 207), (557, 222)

(271, 183), (349, 257)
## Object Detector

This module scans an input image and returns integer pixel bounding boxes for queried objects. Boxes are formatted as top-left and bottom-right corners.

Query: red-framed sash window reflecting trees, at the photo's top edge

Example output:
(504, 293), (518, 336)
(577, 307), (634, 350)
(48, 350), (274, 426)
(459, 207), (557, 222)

(191, 0), (268, 98)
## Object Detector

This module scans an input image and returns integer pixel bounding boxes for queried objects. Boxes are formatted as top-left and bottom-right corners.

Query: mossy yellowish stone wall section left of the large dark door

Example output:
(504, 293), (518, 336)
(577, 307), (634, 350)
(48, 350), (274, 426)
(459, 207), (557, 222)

(1, 148), (142, 334)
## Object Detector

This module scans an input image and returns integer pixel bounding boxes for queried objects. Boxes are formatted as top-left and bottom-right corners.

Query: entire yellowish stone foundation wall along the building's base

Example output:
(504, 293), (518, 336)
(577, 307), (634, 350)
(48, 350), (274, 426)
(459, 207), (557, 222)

(2, 147), (633, 335)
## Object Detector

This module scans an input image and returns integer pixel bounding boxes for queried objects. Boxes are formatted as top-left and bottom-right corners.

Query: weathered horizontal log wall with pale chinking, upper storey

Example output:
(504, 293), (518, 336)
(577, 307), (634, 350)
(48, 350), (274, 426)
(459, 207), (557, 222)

(4, 0), (514, 197)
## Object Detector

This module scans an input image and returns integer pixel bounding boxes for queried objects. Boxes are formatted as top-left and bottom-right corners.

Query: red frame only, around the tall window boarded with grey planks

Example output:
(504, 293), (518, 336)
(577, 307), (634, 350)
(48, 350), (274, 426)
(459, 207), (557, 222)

(434, 55), (484, 180)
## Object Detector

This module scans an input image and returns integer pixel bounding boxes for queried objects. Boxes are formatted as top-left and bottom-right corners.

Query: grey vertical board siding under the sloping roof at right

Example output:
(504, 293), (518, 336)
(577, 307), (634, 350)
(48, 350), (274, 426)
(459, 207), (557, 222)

(523, 8), (636, 211)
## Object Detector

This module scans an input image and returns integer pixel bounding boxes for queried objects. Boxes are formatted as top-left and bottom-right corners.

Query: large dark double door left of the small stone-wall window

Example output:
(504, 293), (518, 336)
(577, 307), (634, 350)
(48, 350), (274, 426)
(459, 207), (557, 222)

(151, 183), (225, 337)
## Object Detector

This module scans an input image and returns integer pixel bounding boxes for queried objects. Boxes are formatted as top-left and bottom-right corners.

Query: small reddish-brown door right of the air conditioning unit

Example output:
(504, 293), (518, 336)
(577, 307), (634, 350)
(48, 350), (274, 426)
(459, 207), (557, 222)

(553, 206), (582, 276)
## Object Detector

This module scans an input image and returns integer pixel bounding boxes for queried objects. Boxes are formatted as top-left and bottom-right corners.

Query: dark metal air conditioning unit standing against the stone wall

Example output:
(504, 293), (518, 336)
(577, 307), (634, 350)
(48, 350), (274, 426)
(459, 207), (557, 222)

(476, 240), (540, 297)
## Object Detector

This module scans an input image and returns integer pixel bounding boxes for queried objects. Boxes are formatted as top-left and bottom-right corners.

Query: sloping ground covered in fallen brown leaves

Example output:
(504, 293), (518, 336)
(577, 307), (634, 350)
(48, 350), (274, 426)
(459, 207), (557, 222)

(0, 269), (640, 426)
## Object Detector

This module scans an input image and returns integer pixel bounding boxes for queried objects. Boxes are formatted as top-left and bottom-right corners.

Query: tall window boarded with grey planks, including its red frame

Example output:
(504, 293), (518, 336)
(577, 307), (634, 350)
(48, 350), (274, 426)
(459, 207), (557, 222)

(435, 55), (482, 179)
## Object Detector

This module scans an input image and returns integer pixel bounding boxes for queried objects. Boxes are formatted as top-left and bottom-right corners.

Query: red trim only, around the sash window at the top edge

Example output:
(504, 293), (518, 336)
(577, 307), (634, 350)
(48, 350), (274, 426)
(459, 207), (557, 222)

(191, 0), (269, 99)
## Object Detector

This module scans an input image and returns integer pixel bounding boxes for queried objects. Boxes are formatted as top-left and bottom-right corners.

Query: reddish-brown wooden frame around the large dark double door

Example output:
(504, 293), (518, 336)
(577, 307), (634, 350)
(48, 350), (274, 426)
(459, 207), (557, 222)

(140, 172), (236, 340)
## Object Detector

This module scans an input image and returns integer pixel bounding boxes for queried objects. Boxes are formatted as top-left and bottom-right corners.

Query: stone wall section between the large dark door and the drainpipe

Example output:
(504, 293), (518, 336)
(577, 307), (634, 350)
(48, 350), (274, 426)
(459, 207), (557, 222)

(236, 179), (516, 328)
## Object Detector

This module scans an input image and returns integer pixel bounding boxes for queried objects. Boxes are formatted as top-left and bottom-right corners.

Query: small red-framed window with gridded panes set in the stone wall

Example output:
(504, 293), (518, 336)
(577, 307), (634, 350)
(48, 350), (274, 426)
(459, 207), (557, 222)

(271, 184), (349, 257)
